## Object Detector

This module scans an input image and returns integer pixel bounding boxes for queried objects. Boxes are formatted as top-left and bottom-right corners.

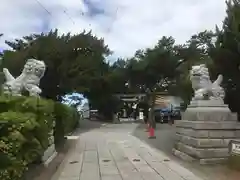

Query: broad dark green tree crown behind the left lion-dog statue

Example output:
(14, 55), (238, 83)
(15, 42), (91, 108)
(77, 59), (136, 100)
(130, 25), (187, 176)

(1, 30), (111, 100)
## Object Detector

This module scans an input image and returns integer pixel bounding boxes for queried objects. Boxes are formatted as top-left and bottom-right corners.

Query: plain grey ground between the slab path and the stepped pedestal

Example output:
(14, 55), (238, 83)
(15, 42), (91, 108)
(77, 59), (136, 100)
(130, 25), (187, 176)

(133, 124), (240, 180)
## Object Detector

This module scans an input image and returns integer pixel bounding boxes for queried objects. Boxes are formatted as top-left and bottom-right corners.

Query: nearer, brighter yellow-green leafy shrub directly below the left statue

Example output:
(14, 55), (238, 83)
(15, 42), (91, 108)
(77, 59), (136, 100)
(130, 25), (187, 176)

(0, 97), (53, 180)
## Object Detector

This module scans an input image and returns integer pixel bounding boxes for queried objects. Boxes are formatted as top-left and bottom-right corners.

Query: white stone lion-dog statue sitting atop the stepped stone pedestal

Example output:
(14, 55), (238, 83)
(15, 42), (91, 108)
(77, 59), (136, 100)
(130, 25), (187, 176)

(190, 64), (225, 101)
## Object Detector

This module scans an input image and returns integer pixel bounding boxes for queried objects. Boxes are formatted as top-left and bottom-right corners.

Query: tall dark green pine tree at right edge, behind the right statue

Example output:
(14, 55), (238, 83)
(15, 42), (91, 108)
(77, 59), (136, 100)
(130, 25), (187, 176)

(213, 0), (240, 114)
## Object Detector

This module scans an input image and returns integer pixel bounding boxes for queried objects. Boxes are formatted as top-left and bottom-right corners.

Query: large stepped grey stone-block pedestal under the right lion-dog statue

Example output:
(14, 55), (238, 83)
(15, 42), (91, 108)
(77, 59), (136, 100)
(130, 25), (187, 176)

(173, 100), (240, 164)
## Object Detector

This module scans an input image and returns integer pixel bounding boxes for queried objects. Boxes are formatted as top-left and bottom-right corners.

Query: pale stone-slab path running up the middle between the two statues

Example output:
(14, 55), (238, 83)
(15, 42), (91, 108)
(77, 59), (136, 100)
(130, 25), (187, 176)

(52, 124), (202, 180)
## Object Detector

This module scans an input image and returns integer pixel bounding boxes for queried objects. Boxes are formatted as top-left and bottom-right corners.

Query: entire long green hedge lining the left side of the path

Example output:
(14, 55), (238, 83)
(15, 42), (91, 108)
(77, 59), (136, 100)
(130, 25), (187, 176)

(0, 96), (79, 180)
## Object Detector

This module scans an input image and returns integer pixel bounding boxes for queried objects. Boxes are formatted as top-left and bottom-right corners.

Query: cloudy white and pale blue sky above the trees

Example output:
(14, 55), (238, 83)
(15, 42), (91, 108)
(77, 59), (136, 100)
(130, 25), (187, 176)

(0, 0), (226, 59)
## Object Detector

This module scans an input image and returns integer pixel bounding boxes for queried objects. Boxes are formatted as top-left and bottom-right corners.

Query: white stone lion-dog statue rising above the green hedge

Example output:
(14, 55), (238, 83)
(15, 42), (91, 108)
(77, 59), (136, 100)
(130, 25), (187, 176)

(3, 59), (46, 96)
